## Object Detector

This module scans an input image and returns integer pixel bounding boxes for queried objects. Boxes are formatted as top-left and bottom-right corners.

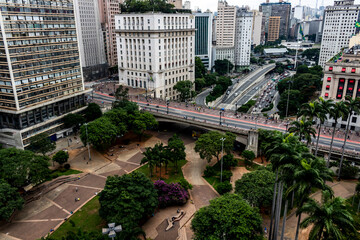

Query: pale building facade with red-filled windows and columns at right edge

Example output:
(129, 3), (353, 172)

(321, 45), (360, 131)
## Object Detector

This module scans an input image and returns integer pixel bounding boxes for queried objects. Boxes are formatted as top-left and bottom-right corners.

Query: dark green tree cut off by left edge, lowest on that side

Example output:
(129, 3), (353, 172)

(0, 179), (24, 220)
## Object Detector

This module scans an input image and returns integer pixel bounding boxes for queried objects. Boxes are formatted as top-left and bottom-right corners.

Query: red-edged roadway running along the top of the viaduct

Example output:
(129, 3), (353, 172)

(90, 93), (360, 152)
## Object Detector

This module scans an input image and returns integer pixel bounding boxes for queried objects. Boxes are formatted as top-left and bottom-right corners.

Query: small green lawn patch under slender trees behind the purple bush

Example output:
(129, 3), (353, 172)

(135, 160), (187, 183)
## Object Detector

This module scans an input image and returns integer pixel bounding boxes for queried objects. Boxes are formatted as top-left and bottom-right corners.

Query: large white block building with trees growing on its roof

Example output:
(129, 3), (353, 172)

(116, 13), (195, 99)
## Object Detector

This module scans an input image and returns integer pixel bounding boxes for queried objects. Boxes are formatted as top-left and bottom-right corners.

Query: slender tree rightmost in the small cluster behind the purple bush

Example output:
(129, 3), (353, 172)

(166, 134), (186, 172)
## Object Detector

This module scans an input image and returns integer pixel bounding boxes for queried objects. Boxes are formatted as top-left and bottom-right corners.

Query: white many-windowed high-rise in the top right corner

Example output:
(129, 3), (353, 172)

(319, 0), (360, 67)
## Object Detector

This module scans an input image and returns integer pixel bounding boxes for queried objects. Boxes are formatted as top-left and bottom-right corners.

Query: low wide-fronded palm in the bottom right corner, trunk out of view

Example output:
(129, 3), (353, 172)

(299, 190), (356, 240)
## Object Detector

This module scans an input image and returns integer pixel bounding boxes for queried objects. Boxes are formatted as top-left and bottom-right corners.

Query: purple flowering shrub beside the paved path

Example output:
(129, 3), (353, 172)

(154, 180), (189, 207)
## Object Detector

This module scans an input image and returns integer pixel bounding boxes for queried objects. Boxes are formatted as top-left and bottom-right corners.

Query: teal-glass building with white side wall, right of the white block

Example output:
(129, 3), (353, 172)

(195, 12), (213, 70)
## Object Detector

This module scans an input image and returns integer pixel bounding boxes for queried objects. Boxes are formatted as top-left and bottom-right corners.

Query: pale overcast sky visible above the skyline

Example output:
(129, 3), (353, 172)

(191, 0), (360, 12)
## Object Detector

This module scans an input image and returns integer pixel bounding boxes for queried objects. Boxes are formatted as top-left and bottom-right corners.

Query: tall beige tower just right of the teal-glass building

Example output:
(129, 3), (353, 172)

(216, 0), (236, 48)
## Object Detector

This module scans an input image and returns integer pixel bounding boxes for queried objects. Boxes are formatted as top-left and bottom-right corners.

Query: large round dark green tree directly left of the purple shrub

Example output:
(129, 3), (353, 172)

(99, 172), (158, 240)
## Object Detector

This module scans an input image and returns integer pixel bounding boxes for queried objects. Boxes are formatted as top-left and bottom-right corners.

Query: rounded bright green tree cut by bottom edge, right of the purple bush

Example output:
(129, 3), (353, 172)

(191, 194), (263, 240)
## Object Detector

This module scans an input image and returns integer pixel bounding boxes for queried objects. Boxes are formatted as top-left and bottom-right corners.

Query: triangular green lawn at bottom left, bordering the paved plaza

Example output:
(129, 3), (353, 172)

(51, 196), (106, 239)
